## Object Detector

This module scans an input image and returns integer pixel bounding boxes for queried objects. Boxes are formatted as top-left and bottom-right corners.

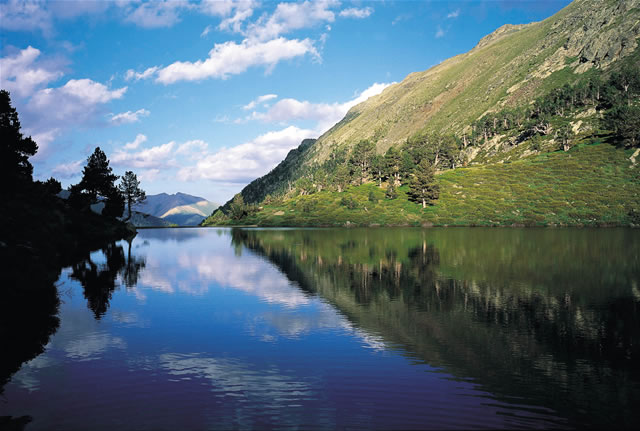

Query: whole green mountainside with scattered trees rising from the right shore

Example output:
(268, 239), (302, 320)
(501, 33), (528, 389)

(203, 0), (640, 225)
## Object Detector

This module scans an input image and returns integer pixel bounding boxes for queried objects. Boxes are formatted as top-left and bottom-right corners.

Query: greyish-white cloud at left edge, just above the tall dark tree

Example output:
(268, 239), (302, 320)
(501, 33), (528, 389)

(0, 46), (62, 97)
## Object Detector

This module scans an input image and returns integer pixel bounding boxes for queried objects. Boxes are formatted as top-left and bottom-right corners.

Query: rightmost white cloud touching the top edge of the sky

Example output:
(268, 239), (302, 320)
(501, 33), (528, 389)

(247, 0), (340, 40)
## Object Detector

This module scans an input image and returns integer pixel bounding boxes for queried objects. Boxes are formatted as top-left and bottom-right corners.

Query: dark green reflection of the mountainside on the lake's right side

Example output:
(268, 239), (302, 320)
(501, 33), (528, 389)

(233, 229), (640, 426)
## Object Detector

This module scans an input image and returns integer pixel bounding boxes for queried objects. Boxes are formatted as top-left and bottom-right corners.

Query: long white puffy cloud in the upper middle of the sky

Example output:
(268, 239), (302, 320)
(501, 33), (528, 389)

(156, 38), (319, 84)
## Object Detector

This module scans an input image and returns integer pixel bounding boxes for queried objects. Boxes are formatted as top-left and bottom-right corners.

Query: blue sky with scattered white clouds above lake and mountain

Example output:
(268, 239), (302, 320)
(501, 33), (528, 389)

(0, 0), (569, 203)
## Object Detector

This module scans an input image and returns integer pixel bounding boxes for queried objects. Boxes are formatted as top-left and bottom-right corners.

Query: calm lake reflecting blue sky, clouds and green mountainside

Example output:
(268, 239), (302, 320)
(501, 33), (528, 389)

(0, 228), (640, 430)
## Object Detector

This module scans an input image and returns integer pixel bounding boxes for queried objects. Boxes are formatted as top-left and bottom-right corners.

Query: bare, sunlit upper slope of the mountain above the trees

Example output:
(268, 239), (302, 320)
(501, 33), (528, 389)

(311, 0), (640, 161)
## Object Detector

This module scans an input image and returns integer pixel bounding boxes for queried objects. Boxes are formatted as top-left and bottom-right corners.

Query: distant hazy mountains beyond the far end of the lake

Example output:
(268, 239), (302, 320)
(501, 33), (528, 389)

(133, 193), (219, 226)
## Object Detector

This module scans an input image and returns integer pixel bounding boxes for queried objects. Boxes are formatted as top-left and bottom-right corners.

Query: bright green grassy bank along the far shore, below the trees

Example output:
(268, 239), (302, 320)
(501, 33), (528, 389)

(205, 143), (640, 226)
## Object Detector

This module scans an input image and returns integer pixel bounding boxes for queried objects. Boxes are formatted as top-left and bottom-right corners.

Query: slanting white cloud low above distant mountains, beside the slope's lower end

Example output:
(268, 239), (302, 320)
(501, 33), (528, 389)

(177, 126), (317, 183)
